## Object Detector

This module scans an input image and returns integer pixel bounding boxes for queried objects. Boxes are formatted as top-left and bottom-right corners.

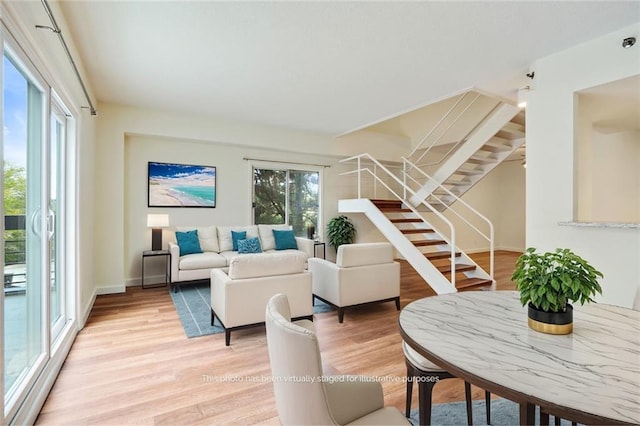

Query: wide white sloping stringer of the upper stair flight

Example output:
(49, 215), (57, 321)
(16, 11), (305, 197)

(409, 103), (520, 207)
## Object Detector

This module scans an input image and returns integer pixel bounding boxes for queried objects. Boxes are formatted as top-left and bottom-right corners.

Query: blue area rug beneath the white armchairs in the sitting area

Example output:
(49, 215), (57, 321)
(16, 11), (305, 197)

(169, 281), (332, 338)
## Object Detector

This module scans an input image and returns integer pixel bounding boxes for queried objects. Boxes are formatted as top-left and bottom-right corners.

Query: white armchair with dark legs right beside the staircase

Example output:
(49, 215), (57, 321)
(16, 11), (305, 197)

(308, 243), (400, 323)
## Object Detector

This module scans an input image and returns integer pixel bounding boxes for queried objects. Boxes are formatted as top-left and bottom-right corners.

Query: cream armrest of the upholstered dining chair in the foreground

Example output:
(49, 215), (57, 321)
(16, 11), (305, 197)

(324, 376), (384, 425)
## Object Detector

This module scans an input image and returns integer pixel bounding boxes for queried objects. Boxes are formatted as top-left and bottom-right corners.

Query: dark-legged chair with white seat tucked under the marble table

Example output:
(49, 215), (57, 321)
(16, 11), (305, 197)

(402, 341), (491, 425)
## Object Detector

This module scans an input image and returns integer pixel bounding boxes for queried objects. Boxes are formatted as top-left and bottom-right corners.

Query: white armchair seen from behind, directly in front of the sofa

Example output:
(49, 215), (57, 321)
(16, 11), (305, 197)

(211, 251), (313, 346)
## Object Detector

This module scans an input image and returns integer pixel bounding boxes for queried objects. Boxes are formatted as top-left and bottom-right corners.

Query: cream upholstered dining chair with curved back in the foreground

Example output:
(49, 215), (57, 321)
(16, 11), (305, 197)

(265, 294), (410, 425)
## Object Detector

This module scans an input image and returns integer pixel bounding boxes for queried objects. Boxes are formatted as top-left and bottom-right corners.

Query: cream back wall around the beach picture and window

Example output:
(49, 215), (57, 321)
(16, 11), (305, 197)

(92, 104), (412, 294)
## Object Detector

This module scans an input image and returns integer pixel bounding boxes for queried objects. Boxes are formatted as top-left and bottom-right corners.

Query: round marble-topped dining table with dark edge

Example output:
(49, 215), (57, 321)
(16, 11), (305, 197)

(399, 291), (640, 424)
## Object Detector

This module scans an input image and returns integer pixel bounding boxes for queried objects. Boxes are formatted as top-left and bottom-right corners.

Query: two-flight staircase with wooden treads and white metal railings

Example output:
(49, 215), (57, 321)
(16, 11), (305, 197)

(338, 91), (525, 294)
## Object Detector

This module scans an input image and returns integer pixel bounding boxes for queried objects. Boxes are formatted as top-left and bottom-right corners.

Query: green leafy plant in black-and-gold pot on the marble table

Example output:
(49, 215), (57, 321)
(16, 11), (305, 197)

(511, 248), (603, 334)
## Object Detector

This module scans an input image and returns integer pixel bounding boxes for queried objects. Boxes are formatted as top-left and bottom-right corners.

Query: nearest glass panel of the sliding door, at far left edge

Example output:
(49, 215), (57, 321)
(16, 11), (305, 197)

(3, 53), (48, 407)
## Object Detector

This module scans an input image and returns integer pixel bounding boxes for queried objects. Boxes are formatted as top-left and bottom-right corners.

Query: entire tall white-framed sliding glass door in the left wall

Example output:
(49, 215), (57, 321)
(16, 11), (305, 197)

(2, 45), (70, 419)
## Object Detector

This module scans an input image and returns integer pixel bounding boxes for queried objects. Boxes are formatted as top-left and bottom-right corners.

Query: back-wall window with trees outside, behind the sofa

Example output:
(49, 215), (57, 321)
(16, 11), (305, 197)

(253, 166), (320, 237)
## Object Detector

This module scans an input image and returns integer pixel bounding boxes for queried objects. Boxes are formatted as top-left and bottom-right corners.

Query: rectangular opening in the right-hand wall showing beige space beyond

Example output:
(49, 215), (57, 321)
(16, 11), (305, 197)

(574, 75), (640, 223)
